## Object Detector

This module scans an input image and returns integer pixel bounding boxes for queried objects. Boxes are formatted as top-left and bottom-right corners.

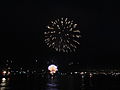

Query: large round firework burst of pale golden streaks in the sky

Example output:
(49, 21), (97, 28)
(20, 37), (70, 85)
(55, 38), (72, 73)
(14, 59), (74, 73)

(44, 18), (81, 53)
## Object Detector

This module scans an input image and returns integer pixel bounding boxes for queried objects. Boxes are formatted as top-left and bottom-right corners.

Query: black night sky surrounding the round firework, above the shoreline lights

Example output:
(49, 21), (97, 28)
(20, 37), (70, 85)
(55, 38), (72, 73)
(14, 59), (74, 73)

(0, 0), (120, 67)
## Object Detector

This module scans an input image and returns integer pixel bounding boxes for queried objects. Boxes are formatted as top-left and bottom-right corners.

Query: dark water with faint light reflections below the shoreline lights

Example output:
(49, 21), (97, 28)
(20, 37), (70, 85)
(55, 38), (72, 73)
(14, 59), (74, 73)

(0, 75), (120, 90)
